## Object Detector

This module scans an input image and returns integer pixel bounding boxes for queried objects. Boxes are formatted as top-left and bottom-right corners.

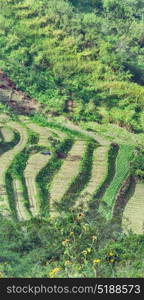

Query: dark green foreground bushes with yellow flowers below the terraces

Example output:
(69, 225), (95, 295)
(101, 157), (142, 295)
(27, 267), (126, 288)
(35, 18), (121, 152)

(0, 213), (144, 278)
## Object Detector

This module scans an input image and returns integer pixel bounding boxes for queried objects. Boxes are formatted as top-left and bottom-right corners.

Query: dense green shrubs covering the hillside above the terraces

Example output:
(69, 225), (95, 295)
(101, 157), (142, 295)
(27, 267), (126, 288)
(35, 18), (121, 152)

(0, 0), (144, 131)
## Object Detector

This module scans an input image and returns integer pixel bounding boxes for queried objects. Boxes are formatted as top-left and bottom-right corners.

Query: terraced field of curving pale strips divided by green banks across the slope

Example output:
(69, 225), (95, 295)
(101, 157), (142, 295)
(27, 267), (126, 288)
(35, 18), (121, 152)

(0, 114), (144, 234)
